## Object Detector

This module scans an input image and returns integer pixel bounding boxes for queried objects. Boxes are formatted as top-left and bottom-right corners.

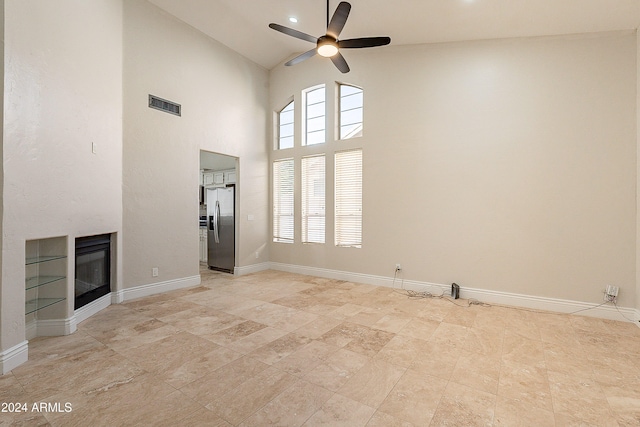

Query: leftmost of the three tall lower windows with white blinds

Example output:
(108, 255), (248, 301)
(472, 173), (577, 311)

(273, 159), (294, 243)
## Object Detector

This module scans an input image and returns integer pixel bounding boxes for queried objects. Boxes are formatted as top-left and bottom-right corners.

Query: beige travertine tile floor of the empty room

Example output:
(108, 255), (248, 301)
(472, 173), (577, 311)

(0, 271), (640, 427)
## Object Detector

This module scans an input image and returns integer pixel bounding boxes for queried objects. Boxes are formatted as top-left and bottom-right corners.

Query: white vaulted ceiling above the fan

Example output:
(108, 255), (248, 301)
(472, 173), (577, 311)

(149, 0), (640, 69)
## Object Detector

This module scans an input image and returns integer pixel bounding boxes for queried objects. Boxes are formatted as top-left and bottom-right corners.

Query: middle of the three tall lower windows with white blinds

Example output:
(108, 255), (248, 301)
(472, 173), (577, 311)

(301, 154), (325, 243)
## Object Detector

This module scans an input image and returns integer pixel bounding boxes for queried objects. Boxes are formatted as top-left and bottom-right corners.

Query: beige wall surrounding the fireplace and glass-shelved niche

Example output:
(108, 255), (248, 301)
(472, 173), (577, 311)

(0, 0), (122, 350)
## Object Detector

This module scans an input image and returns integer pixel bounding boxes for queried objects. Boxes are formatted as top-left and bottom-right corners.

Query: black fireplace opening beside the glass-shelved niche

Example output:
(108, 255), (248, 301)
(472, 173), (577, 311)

(75, 234), (111, 310)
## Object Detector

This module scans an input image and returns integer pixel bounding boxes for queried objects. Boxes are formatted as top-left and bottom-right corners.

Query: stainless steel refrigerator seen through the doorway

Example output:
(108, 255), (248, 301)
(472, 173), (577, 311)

(207, 187), (236, 273)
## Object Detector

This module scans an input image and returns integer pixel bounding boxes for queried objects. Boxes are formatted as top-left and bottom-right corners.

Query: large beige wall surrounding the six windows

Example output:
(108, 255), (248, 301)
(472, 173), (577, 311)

(270, 32), (638, 307)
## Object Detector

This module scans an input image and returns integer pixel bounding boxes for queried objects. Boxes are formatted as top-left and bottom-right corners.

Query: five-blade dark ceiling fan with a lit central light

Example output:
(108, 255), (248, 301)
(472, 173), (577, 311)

(269, 0), (391, 73)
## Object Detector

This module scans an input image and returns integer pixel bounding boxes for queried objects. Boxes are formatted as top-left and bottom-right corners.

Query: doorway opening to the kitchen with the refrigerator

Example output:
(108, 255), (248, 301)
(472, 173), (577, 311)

(199, 150), (238, 274)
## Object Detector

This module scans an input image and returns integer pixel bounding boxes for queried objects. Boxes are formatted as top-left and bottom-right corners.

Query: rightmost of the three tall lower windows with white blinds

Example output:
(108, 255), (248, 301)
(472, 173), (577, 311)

(334, 150), (362, 248)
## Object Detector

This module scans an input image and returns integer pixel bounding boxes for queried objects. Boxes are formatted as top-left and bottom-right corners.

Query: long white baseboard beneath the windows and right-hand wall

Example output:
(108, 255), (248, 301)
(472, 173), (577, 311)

(269, 262), (640, 326)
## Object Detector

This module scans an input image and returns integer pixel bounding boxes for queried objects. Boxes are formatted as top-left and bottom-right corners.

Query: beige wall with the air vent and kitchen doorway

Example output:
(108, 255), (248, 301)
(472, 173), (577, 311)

(123, 0), (269, 288)
